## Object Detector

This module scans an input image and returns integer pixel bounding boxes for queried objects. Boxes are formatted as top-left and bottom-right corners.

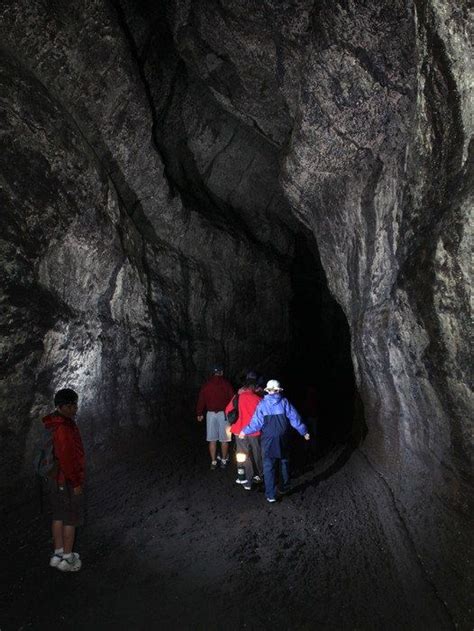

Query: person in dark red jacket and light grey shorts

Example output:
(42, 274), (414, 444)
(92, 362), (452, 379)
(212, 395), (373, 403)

(196, 366), (234, 469)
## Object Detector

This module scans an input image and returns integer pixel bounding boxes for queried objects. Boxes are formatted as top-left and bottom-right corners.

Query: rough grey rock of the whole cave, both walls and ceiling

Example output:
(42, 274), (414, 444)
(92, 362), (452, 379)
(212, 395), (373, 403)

(0, 0), (472, 628)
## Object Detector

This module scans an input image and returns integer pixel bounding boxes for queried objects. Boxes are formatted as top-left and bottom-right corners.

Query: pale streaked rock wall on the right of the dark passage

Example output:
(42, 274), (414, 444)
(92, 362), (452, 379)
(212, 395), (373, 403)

(284, 2), (472, 615)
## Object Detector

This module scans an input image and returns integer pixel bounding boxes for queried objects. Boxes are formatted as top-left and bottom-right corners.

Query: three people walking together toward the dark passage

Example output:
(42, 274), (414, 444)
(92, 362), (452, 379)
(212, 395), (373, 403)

(196, 366), (310, 503)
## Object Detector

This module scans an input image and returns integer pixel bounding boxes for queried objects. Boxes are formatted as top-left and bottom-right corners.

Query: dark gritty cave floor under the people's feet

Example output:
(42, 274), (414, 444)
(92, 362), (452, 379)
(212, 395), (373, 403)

(0, 428), (453, 631)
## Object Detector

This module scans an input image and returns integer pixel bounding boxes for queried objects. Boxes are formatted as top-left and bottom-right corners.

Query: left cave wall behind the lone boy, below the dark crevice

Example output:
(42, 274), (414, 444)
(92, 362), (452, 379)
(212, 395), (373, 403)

(1, 2), (293, 466)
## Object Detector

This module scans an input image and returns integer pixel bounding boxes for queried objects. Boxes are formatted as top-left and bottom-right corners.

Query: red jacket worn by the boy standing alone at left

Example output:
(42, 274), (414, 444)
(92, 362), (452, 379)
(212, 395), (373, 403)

(43, 412), (85, 488)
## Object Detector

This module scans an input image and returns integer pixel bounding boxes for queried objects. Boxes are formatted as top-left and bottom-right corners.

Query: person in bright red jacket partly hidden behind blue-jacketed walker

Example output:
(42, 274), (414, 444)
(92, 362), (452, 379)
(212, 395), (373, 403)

(225, 373), (263, 491)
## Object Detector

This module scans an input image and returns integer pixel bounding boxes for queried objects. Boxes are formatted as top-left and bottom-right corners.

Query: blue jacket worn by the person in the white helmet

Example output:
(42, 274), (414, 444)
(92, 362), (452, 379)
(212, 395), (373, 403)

(242, 393), (308, 458)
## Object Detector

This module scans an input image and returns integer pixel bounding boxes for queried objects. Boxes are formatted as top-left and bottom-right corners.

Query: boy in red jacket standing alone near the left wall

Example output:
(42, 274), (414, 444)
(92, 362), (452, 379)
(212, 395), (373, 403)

(43, 388), (85, 572)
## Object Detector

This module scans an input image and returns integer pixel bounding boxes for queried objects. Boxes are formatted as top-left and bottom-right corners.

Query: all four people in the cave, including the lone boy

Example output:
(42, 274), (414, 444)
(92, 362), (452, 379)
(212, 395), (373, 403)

(36, 366), (310, 572)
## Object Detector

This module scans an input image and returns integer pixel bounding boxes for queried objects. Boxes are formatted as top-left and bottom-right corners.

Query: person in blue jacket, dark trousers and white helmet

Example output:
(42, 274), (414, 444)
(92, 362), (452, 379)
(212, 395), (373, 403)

(239, 379), (310, 502)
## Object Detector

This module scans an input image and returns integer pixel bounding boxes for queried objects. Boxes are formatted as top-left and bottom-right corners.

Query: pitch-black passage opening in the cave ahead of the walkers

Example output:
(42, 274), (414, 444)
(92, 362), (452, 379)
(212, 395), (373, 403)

(285, 235), (364, 452)
